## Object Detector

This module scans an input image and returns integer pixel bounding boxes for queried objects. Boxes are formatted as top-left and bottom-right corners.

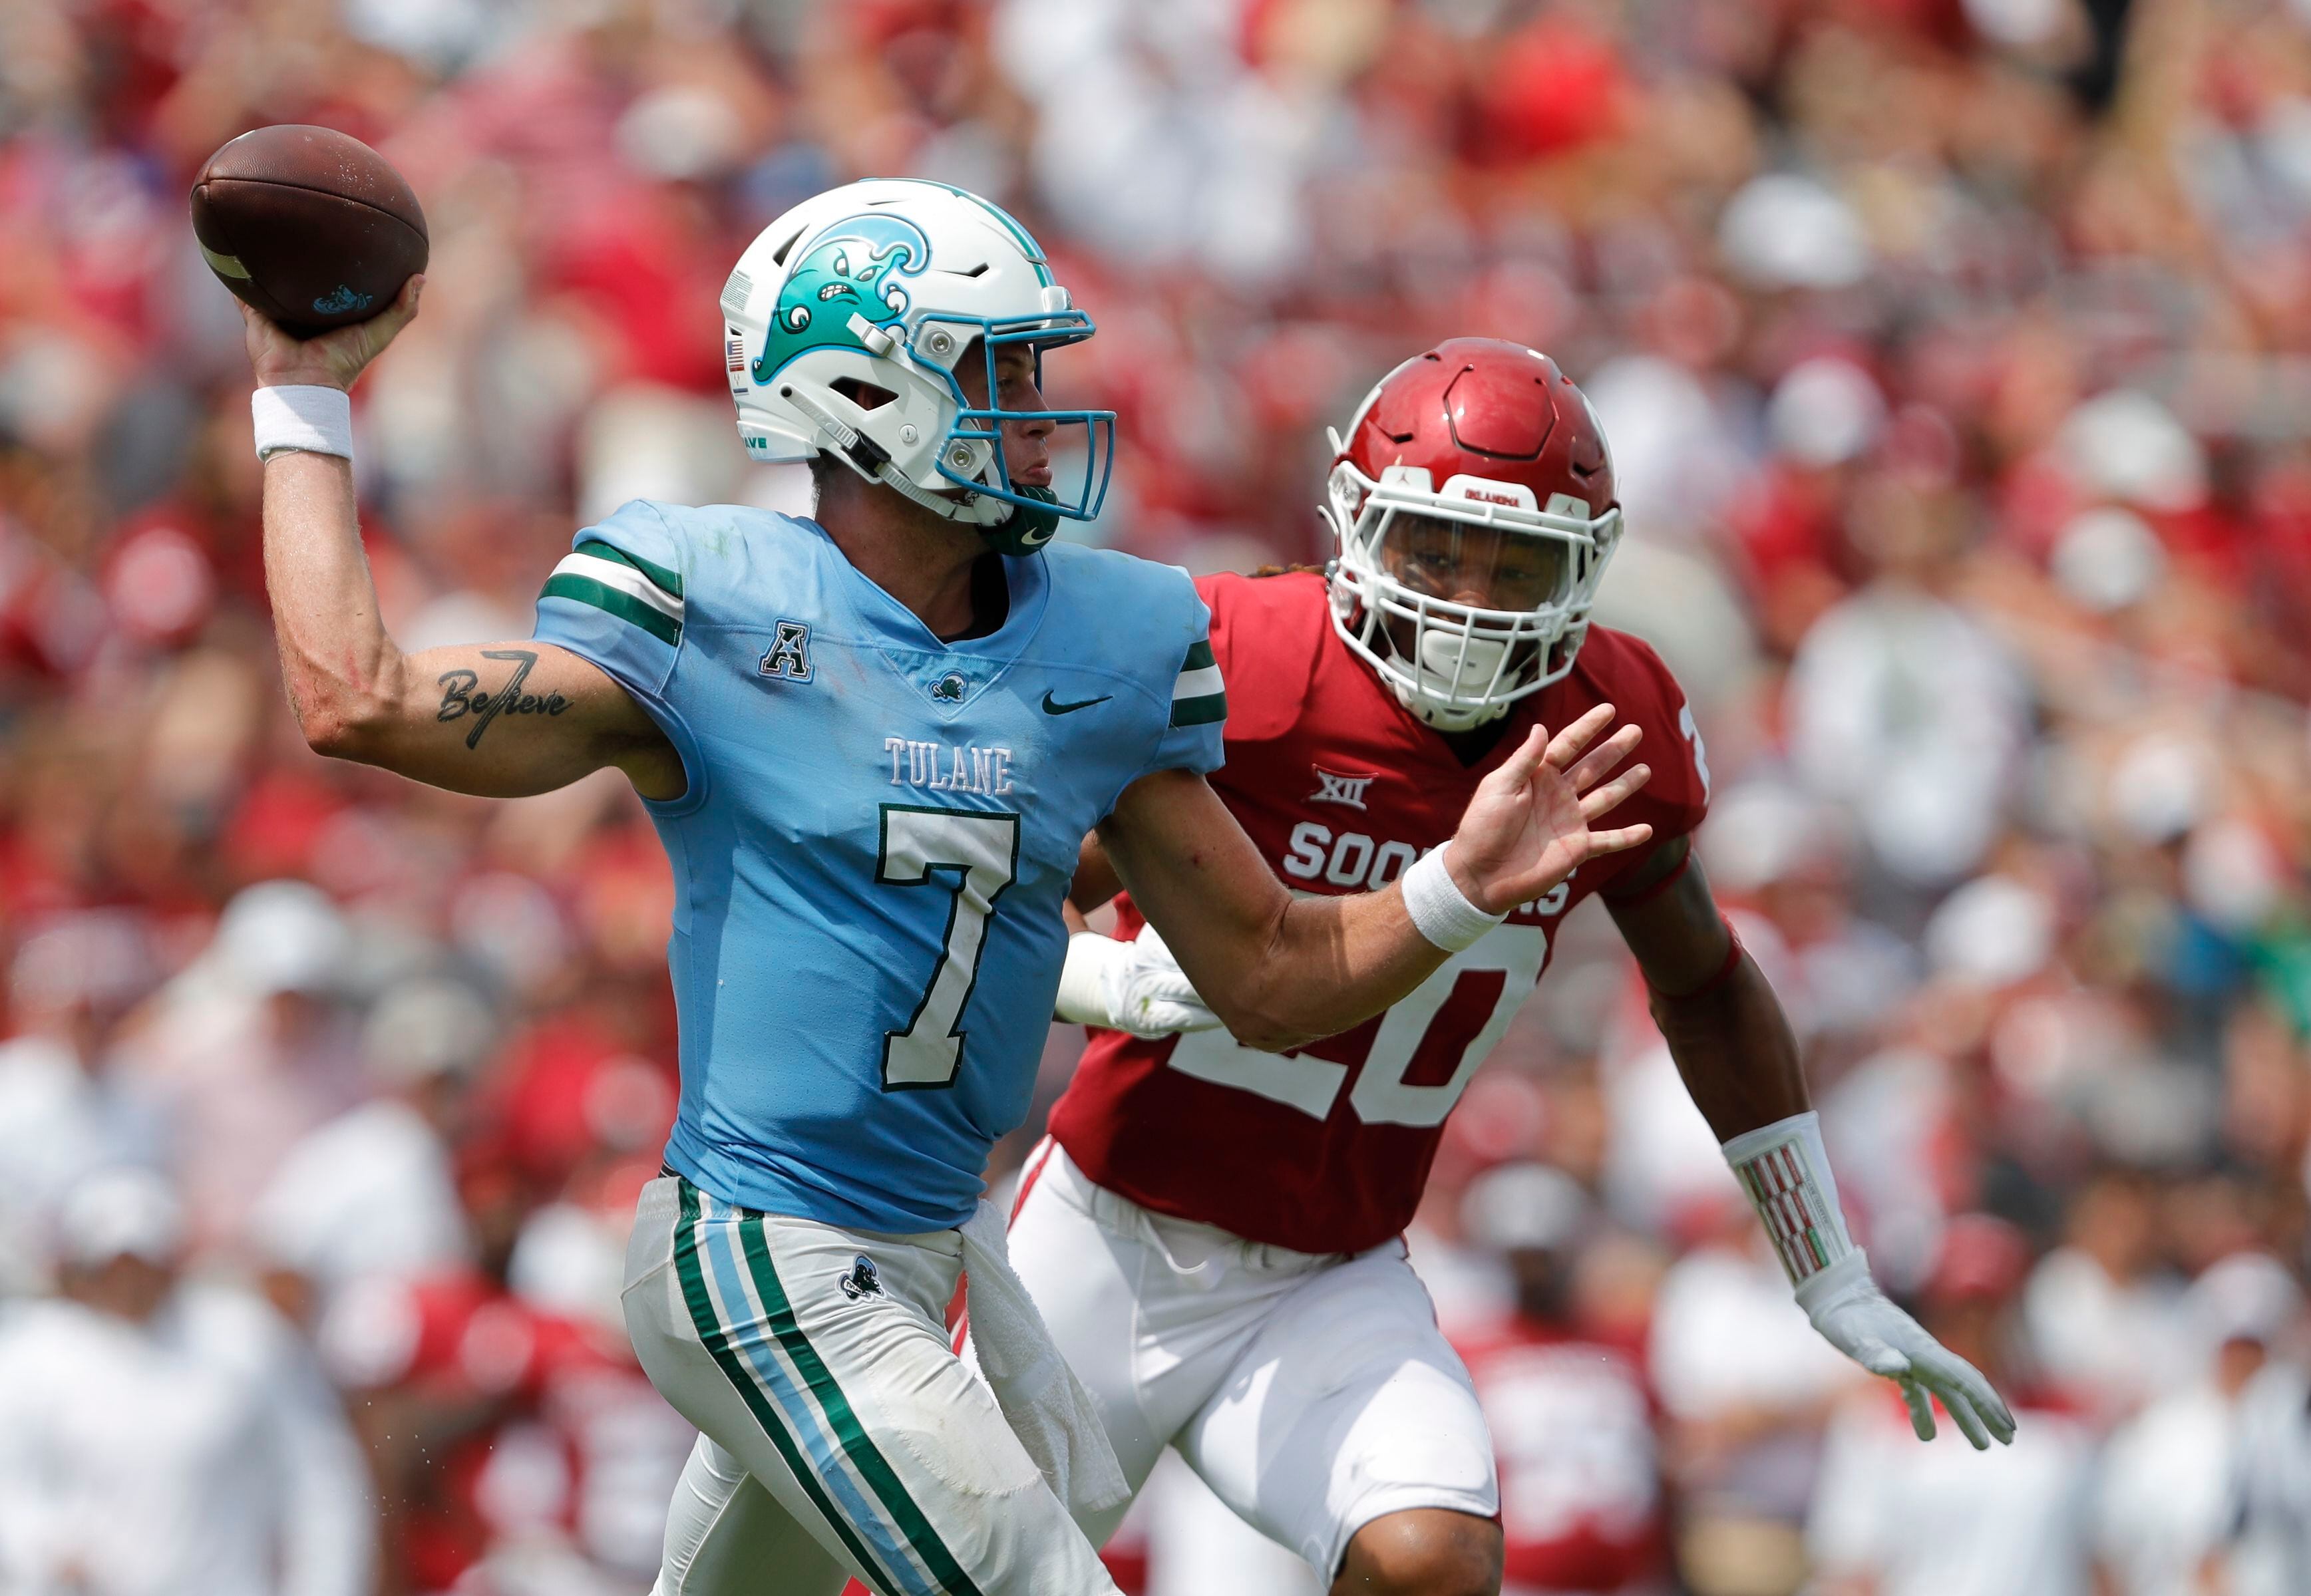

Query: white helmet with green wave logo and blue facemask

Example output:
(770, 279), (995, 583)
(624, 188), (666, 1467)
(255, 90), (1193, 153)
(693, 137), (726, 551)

(721, 178), (1116, 554)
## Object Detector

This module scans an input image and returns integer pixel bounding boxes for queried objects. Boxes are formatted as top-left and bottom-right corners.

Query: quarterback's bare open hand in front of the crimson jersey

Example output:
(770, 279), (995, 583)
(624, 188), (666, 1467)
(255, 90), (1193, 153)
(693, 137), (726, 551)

(1445, 705), (1652, 915)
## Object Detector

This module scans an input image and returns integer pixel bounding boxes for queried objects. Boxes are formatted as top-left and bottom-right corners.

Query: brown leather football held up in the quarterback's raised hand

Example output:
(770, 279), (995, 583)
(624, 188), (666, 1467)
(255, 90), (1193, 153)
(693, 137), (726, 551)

(192, 122), (425, 337)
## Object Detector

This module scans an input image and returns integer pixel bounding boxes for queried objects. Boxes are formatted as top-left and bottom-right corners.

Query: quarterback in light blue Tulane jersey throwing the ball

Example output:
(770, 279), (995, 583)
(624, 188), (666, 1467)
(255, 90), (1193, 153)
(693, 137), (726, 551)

(243, 180), (1648, 1596)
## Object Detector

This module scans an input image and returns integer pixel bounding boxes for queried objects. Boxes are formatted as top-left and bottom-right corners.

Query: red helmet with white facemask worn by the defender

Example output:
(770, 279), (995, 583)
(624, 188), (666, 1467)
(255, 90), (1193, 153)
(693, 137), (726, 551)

(1322, 337), (1620, 732)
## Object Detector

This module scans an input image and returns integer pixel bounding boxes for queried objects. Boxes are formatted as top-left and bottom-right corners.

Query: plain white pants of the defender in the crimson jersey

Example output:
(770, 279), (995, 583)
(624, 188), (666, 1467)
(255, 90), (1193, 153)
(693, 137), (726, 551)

(989, 1141), (1500, 1585)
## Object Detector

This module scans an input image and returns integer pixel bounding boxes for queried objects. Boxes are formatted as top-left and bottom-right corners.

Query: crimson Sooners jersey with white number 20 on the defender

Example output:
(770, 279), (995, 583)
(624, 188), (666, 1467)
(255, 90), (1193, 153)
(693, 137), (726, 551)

(1051, 573), (1708, 1252)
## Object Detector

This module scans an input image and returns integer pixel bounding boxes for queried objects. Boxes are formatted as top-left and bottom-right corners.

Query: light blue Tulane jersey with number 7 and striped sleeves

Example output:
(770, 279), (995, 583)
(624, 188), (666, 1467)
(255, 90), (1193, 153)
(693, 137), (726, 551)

(536, 501), (1227, 1233)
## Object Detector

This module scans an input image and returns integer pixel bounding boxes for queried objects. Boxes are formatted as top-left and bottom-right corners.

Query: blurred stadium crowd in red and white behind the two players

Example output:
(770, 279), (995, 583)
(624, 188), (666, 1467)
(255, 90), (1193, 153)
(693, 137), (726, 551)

(0, 0), (2311, 1596)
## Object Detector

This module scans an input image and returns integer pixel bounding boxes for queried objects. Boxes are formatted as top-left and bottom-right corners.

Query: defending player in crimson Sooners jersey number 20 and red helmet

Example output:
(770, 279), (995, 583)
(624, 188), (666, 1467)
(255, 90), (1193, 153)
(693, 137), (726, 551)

(1010, 339), (2011, 1594)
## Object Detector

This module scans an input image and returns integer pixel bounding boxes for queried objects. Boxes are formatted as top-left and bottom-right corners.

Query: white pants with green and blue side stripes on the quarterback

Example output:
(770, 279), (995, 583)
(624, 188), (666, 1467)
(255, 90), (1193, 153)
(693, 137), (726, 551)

(624, 1176), (1116, 1596)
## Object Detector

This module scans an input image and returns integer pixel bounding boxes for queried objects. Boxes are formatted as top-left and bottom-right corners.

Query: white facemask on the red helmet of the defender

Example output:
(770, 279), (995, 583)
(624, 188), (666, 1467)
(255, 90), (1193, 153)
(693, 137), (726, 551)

(1324, 460), (1620, 732)
